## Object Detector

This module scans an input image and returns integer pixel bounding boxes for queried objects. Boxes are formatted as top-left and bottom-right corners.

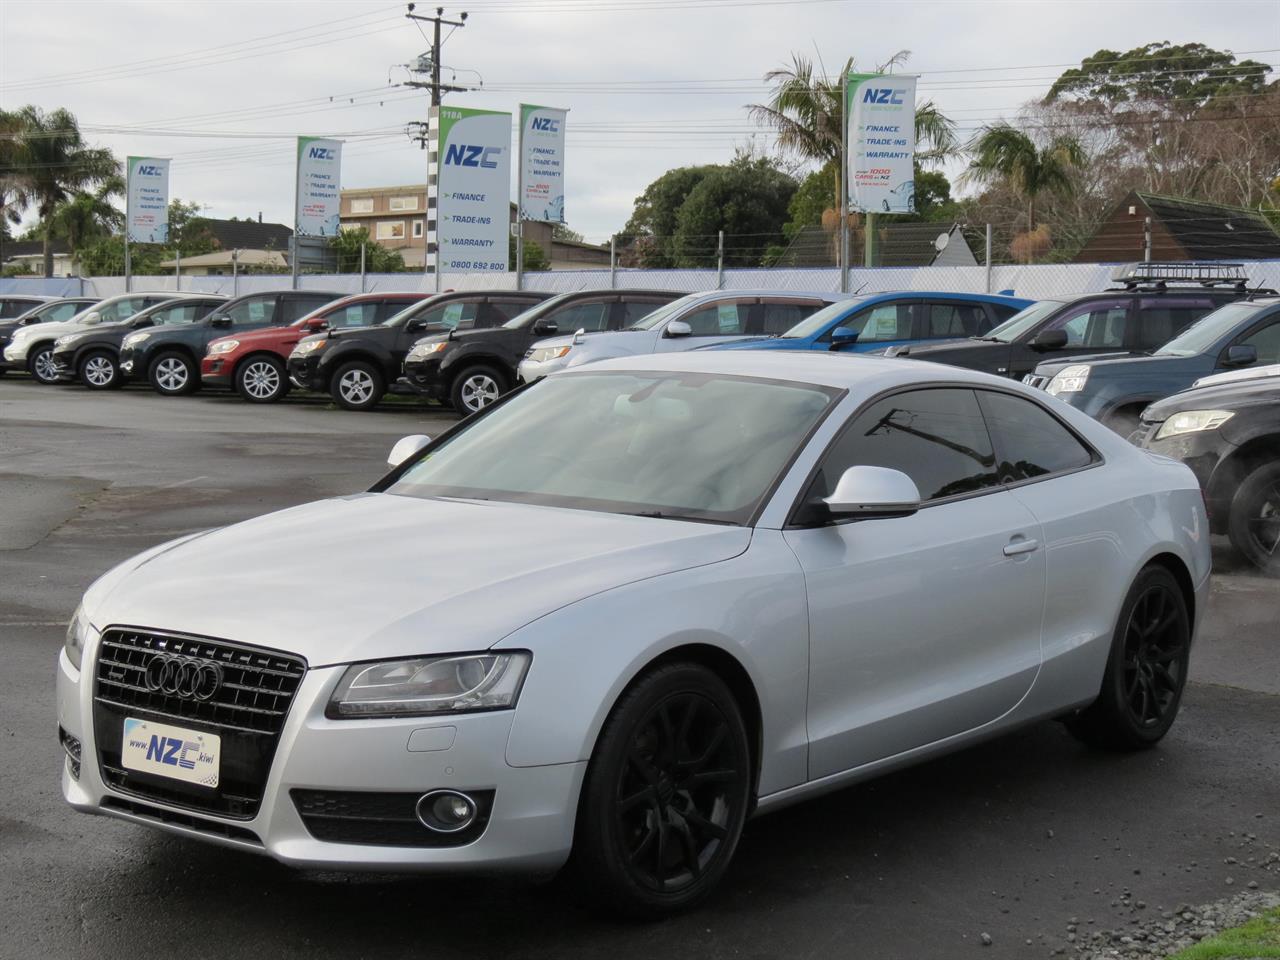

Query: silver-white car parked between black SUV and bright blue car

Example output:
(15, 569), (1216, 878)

(517, 291), (850, 383)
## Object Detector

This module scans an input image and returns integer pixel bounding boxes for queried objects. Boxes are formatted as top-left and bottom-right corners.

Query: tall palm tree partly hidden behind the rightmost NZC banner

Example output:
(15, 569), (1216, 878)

(746, 50), (960, 206)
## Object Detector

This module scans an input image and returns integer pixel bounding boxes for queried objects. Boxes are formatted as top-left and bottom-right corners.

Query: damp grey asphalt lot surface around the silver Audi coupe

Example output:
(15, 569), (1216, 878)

(0, 376), (1280, 960)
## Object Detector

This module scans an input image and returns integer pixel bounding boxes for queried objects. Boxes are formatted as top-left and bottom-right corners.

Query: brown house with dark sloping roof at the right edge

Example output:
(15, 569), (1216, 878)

(1075, 191), (1280, 264)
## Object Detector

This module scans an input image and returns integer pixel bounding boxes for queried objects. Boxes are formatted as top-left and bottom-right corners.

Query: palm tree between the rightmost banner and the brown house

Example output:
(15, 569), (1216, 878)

(961, 123), (1084, 233)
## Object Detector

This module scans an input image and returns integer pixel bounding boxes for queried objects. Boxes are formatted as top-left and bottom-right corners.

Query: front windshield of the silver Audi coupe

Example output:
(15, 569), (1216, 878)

(388, 372), (838, 525)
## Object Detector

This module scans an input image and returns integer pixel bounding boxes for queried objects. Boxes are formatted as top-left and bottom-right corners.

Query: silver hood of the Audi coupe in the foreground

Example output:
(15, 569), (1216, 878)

(84, 494), (751, 667)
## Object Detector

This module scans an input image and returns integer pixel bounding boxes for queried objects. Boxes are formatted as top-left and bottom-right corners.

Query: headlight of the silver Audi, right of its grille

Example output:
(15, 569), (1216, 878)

(325, 652), (531, 719)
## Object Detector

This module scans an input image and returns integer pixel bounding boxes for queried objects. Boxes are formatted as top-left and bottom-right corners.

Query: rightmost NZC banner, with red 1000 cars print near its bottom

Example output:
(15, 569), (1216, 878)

(845, 73), (915, 214)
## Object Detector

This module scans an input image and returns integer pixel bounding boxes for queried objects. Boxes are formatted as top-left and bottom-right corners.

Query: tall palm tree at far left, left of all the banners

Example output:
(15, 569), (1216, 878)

(12, 106), (120, 276)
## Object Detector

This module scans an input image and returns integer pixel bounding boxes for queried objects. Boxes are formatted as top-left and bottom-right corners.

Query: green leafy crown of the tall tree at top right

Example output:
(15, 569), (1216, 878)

(1044, 41), (1271, 113)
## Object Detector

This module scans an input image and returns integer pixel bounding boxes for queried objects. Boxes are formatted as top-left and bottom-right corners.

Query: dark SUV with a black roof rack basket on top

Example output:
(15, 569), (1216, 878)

(884, 262), (1249, 380)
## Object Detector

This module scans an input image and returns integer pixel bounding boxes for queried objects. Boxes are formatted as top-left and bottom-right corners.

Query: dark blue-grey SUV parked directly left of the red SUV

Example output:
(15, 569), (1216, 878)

(120, 291), (343, 397)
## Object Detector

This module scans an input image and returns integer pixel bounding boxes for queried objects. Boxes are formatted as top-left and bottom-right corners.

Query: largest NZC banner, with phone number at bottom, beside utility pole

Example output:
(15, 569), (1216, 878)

(436, 106), (511, 273)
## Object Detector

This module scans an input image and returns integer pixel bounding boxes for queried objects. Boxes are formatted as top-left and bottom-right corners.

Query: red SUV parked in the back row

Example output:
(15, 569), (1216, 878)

(200, 293), (434, 403)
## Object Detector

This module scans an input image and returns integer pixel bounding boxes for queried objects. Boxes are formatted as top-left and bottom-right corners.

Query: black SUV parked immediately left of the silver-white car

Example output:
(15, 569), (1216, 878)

(404, 291), (686, 415)
